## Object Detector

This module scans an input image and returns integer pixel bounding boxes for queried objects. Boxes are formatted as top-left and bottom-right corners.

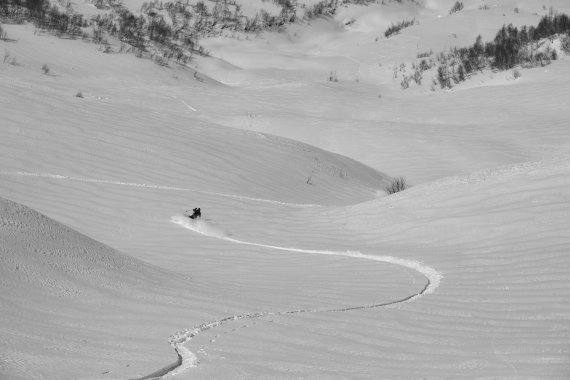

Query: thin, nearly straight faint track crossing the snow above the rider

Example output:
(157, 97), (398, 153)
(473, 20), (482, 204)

(0, 171), (321, 207)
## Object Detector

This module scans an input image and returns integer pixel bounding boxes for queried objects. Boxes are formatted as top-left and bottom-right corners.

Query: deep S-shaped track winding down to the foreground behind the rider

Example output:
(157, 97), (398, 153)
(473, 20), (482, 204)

(158, 215), (443, 380)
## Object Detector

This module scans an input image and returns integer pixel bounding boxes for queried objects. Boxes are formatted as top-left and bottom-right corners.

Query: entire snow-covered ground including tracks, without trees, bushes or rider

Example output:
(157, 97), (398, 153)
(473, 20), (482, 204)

(0, 0), (570, 380)
